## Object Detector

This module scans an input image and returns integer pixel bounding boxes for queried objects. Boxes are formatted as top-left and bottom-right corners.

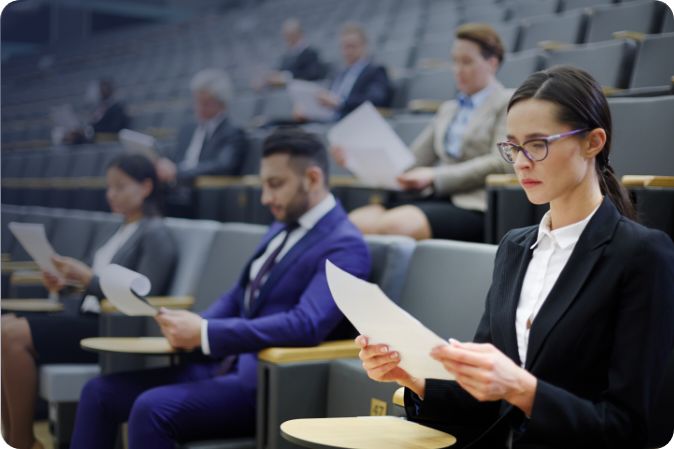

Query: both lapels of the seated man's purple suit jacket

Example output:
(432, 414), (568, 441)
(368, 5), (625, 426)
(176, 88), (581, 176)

(239, 203), (346, 318)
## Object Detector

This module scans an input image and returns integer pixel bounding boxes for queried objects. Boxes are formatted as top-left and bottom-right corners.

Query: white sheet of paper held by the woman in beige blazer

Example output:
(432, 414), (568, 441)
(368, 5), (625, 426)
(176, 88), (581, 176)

(328, 101), (415, 189)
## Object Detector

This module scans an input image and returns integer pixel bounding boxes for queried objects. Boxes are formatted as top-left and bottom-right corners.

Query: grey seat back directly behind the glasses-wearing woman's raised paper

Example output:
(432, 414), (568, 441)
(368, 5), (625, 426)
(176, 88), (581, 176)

(400, 240), (496, 341)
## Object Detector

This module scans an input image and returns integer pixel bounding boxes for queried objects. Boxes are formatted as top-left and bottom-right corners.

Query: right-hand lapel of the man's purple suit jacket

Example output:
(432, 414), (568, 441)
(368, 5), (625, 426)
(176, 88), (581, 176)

(245, 204), (346, 316)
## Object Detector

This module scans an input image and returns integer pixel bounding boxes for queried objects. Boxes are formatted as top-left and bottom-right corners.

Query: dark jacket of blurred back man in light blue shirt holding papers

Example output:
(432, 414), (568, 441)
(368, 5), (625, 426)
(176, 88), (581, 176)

(335, 63), (393, 118)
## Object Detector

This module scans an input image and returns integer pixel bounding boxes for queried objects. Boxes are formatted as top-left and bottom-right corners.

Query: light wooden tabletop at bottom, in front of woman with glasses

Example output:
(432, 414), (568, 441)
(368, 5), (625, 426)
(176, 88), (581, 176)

(281, 416), (456, 449)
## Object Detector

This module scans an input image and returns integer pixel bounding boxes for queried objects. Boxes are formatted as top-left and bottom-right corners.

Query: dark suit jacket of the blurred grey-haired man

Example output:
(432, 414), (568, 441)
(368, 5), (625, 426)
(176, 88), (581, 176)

(168, 118), (247, 181)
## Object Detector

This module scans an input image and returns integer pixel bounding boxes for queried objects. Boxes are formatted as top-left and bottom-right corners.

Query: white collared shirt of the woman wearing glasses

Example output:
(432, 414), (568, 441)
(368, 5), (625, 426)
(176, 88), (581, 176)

(515, 206), (599, 366)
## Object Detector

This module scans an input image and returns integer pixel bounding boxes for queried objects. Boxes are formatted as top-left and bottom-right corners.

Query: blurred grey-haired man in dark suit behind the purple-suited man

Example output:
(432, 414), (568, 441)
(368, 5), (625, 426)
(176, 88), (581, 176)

(156, 69), (247, 217)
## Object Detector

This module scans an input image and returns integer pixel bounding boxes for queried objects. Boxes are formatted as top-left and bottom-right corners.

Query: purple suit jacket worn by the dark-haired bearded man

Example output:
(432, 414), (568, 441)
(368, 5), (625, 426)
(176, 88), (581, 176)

(202, 204), (370, 388)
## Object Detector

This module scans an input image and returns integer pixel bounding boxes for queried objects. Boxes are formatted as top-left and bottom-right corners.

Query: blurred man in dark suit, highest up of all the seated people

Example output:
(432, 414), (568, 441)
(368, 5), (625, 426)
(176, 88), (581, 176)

(267, 18), (326, 86)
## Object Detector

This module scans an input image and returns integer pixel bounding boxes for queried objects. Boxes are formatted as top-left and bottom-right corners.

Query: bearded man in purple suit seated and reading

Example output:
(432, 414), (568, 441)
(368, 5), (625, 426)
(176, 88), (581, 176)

(71, 129), (370, 449)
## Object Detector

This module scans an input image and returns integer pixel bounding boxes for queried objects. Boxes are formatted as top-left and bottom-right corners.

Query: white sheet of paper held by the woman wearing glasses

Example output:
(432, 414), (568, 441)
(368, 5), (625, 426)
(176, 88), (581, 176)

(325, 260), (454, 380)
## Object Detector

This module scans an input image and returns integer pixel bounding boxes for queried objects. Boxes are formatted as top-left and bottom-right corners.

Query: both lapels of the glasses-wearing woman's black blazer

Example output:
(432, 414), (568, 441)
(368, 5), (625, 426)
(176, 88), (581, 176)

(495, 198), (621, 371)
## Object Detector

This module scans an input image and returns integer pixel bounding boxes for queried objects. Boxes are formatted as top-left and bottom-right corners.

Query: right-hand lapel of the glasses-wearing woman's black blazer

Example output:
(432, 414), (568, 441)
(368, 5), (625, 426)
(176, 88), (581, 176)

(526, 198), (620, 370)
